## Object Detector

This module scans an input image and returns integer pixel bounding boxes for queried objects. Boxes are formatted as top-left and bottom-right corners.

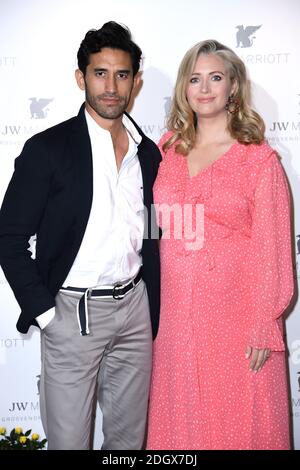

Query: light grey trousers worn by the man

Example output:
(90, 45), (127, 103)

(40, 281), (152, 450)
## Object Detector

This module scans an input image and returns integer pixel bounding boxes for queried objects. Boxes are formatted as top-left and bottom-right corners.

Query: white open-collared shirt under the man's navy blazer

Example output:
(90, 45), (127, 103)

(36, 111), (144, 328)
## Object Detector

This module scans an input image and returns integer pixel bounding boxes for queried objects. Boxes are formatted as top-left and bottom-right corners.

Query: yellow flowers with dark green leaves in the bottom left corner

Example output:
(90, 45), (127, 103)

(0, 427), (47, 450)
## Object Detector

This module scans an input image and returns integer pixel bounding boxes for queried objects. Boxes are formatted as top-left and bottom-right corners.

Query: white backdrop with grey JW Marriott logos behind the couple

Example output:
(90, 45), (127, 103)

(0, 0), (300, 449)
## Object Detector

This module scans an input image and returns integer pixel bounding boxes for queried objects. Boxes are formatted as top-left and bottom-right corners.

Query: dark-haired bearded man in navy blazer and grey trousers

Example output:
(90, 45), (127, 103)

(0, 21), (161, 449)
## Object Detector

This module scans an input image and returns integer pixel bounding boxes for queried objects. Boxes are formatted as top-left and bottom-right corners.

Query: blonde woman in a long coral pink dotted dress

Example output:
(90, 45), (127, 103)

(148, 40), (293, 449)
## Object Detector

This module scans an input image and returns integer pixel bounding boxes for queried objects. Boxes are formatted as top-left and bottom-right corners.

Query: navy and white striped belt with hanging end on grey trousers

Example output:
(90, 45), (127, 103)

(60, 269), (142, 336)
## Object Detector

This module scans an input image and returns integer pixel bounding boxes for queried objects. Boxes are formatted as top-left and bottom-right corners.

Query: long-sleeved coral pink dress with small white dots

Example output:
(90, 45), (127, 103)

(147, 133), (293, 450)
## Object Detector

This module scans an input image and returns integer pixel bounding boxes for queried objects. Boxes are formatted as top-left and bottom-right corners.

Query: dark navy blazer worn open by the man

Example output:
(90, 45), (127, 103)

(0, 105), (161, 337)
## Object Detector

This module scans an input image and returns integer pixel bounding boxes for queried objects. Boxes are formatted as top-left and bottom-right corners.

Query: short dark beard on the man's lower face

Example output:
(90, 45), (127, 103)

(86, 90), (130, 119)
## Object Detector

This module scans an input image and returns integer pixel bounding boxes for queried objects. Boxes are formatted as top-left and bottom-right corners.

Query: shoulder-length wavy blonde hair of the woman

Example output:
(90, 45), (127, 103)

(163, 39), (265, 155)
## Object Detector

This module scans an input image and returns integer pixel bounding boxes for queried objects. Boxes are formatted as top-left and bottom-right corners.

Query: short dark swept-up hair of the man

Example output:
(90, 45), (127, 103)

(77, 21), (142, 76)
